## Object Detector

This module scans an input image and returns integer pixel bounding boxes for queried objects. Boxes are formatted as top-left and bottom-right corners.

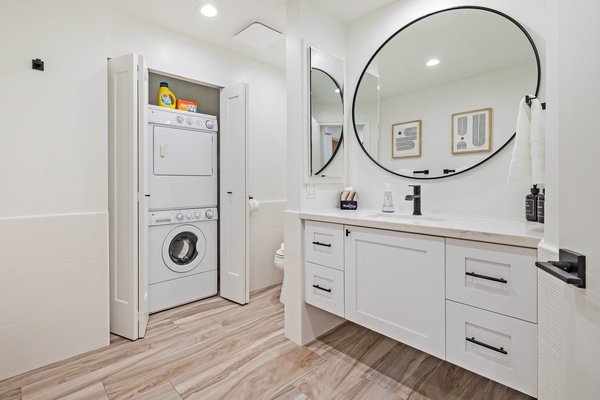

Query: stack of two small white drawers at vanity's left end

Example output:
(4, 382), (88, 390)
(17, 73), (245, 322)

(304, 221), (344, 317)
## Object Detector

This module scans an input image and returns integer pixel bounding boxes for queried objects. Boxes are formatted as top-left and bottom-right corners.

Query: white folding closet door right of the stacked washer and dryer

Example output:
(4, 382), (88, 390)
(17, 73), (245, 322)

(219, 83), (250, 304)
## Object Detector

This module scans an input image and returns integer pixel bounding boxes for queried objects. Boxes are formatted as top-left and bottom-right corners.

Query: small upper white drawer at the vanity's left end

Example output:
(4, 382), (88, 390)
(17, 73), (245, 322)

(304, 221), (344, 270)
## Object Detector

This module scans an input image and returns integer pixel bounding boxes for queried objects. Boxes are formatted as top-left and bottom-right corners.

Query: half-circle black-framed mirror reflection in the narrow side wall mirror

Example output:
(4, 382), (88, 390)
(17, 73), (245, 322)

(310, 67), (344, 175)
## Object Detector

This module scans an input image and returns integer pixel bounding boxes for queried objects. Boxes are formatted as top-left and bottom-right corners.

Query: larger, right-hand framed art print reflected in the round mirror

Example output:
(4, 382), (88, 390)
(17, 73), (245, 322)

(452, 108), (492, 154)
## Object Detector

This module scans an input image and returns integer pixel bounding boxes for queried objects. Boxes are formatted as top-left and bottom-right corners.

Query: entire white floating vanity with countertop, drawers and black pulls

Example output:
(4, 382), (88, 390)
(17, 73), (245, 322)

(304, 213), (539, 397)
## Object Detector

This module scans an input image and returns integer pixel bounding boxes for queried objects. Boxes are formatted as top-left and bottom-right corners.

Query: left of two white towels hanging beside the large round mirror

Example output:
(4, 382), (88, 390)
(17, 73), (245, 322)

(508, 98), (531, 183)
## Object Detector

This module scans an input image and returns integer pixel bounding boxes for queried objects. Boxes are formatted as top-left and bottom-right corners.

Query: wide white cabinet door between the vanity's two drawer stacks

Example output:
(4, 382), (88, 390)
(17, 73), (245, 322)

(345, 226), (445, 358)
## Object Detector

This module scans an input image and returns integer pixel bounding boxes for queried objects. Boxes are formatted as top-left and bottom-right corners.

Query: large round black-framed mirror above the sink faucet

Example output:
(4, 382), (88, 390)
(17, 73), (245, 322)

(352, 6), (540, 179)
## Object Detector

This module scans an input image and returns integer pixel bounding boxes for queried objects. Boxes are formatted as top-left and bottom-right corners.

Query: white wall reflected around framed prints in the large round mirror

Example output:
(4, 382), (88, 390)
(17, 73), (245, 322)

(378, 66), (536, 176)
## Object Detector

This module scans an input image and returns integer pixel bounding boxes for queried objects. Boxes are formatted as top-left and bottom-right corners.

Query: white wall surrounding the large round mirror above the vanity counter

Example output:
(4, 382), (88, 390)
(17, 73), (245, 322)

(344, 0), (546, 219)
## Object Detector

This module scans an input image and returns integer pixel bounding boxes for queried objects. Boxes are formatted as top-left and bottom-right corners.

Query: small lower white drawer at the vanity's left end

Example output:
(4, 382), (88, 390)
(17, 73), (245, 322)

(305, 262), (344, 317)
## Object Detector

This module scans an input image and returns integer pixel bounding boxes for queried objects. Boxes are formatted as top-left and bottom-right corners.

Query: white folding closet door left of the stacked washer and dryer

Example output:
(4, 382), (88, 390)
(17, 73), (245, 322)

(108, 54), (148, 340)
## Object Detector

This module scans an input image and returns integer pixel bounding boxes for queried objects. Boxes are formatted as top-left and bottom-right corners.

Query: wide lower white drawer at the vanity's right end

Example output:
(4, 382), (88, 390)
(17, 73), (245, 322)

(446, 300), (537, 397)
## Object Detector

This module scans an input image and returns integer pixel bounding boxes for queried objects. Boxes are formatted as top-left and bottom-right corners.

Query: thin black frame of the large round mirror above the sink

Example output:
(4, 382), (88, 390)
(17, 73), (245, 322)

(352, 6), (541, 180)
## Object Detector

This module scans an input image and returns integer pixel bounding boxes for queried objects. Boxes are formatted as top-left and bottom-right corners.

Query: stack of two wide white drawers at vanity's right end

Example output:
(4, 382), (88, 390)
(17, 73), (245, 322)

(446, 239), (537, 397)
